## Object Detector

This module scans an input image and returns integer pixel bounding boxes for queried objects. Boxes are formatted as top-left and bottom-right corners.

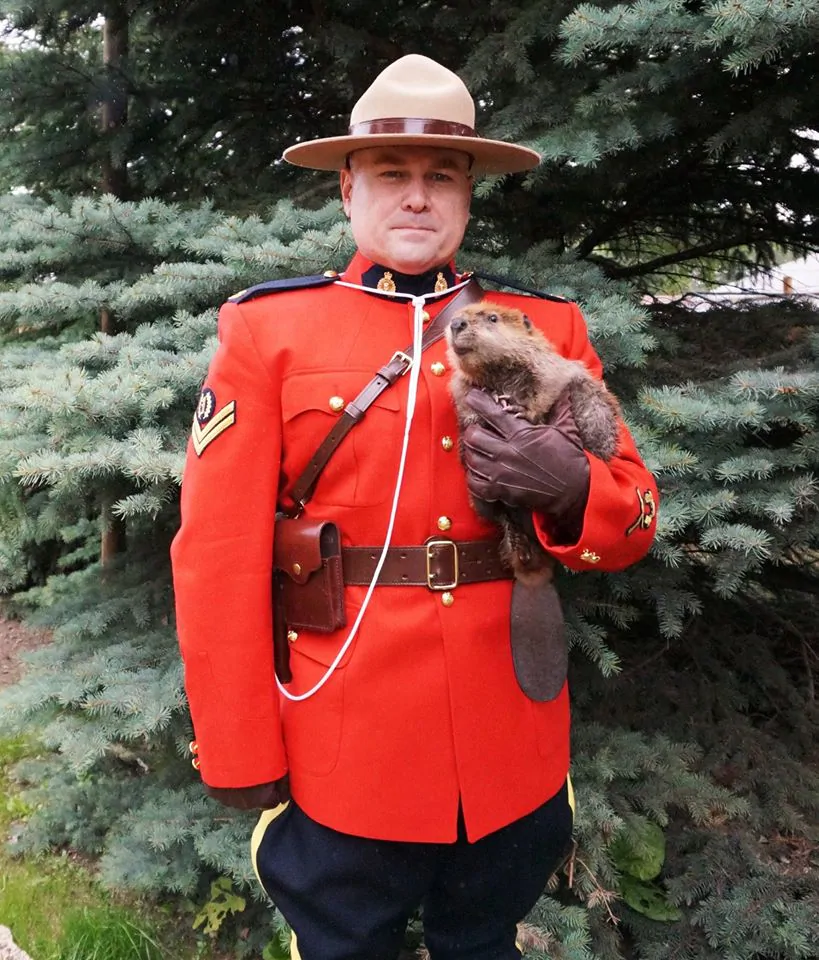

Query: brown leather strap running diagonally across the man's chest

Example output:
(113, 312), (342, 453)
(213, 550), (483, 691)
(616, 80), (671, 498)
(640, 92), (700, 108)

(290, 278), (483, 516)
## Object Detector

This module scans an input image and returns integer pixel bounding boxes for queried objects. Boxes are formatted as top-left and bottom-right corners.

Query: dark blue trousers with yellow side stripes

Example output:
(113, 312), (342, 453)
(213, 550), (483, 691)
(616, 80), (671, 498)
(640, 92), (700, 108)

(254, 784), (572, 960)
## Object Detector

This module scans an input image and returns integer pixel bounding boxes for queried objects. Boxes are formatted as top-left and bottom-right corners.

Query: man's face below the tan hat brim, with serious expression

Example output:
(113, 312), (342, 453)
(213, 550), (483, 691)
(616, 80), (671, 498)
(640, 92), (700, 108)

(341, 147), (472, 274)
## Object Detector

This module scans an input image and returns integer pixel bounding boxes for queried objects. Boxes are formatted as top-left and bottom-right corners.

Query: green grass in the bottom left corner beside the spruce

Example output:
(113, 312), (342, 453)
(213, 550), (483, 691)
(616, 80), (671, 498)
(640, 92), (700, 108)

(0, 738), (219, 960)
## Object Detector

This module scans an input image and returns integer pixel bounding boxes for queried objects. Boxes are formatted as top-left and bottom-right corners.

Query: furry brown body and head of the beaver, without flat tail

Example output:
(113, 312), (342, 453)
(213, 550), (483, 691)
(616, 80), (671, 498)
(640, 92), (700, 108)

(446, 301), (620, 585)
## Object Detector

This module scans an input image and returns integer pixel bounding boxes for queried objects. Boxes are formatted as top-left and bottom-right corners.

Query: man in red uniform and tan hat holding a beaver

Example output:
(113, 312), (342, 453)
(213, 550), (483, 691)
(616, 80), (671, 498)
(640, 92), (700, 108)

(173, 56), (657, 960)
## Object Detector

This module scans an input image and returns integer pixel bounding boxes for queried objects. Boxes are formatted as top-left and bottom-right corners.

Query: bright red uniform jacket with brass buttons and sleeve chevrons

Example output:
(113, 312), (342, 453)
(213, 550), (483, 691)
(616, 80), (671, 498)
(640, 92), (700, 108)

(172, 256), (657, 842)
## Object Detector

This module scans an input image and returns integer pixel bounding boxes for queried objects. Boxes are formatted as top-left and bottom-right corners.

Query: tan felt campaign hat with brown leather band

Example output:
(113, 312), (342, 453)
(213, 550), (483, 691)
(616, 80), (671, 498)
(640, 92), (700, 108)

(284, 53), (540, 174)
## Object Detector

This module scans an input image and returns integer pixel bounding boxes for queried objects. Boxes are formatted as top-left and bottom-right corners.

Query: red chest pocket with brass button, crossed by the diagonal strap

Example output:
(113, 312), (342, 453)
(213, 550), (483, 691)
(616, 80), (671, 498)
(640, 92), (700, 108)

(282, 370), (403, 507)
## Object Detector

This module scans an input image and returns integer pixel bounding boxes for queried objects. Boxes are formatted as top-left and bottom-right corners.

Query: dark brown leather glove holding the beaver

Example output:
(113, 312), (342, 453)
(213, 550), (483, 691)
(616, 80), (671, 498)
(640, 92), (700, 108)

(463, 389), (590, 542)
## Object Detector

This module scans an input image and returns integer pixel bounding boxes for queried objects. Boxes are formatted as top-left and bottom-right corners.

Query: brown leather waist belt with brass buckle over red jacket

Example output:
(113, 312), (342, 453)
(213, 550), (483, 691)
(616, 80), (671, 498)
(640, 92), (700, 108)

(341, 537), (512, 590)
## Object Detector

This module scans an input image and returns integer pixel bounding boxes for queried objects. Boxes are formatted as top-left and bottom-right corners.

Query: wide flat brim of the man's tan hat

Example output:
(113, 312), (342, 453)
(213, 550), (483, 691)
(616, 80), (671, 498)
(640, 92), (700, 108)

(282, 133), (540, 176)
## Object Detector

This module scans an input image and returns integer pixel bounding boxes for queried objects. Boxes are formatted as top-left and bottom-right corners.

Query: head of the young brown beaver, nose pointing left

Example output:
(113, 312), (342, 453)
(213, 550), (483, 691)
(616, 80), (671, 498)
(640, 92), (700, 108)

(446, 301), (542, 385)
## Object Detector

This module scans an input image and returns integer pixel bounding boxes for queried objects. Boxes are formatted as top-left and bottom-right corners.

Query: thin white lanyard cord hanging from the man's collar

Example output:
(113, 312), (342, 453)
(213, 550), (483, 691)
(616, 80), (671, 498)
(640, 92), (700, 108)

(276, 278), (469, 703)
